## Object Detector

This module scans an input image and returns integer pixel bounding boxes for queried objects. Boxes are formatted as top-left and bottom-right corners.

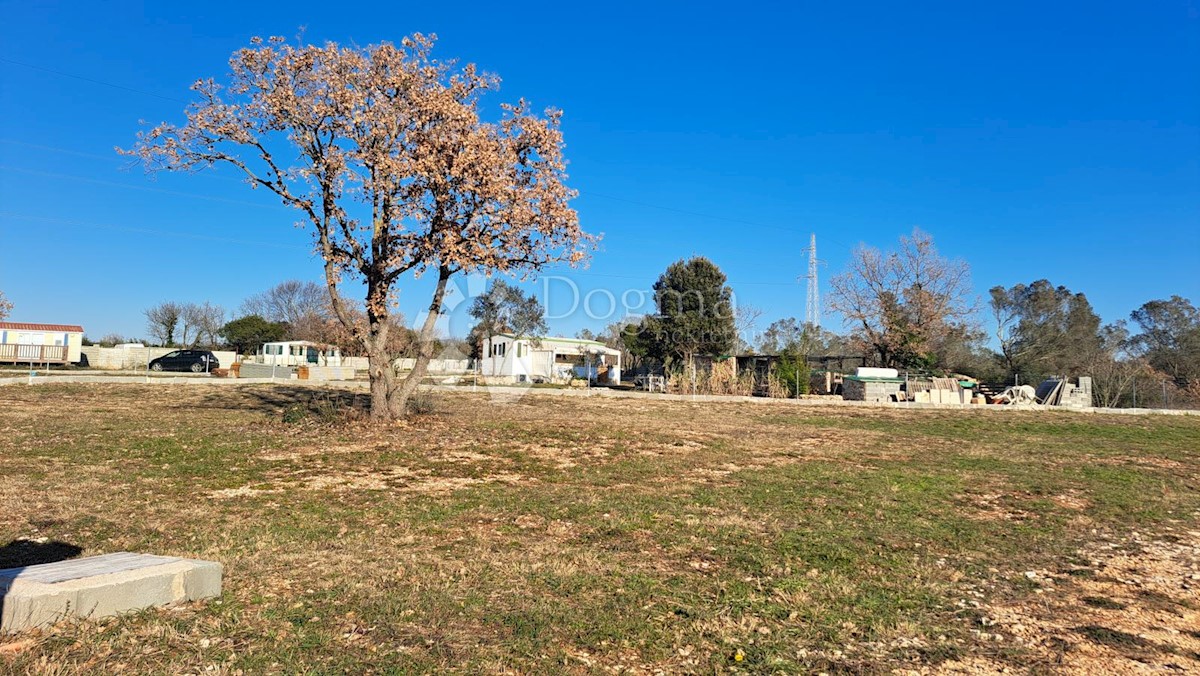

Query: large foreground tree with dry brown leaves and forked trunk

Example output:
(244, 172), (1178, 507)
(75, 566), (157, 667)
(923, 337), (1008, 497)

(122, 34), (594, 420)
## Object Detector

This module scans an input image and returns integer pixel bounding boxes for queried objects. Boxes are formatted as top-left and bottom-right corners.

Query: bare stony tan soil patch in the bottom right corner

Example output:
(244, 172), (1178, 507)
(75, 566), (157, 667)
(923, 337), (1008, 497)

(911, 531), (1200, 674)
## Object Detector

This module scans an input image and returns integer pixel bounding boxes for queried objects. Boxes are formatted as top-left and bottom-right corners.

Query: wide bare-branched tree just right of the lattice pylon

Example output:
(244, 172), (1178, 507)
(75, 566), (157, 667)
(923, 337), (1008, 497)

(829, 228), (974, 366)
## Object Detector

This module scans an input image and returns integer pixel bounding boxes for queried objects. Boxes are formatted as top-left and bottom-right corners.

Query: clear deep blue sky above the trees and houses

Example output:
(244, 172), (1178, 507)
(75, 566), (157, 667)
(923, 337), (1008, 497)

(0, 0), (1200, 337)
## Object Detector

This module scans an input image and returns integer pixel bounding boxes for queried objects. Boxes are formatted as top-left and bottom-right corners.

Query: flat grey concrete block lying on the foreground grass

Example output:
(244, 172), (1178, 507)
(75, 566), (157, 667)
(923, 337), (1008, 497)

(0, 551), (221, 633)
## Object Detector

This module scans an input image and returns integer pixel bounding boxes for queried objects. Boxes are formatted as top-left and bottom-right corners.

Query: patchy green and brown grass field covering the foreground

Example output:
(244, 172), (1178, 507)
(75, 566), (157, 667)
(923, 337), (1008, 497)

(0, 385), (1200, 674)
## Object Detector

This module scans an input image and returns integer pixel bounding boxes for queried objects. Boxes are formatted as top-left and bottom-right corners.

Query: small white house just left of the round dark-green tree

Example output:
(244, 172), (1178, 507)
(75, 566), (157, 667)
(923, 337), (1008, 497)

(480, 334), (620, 384)
